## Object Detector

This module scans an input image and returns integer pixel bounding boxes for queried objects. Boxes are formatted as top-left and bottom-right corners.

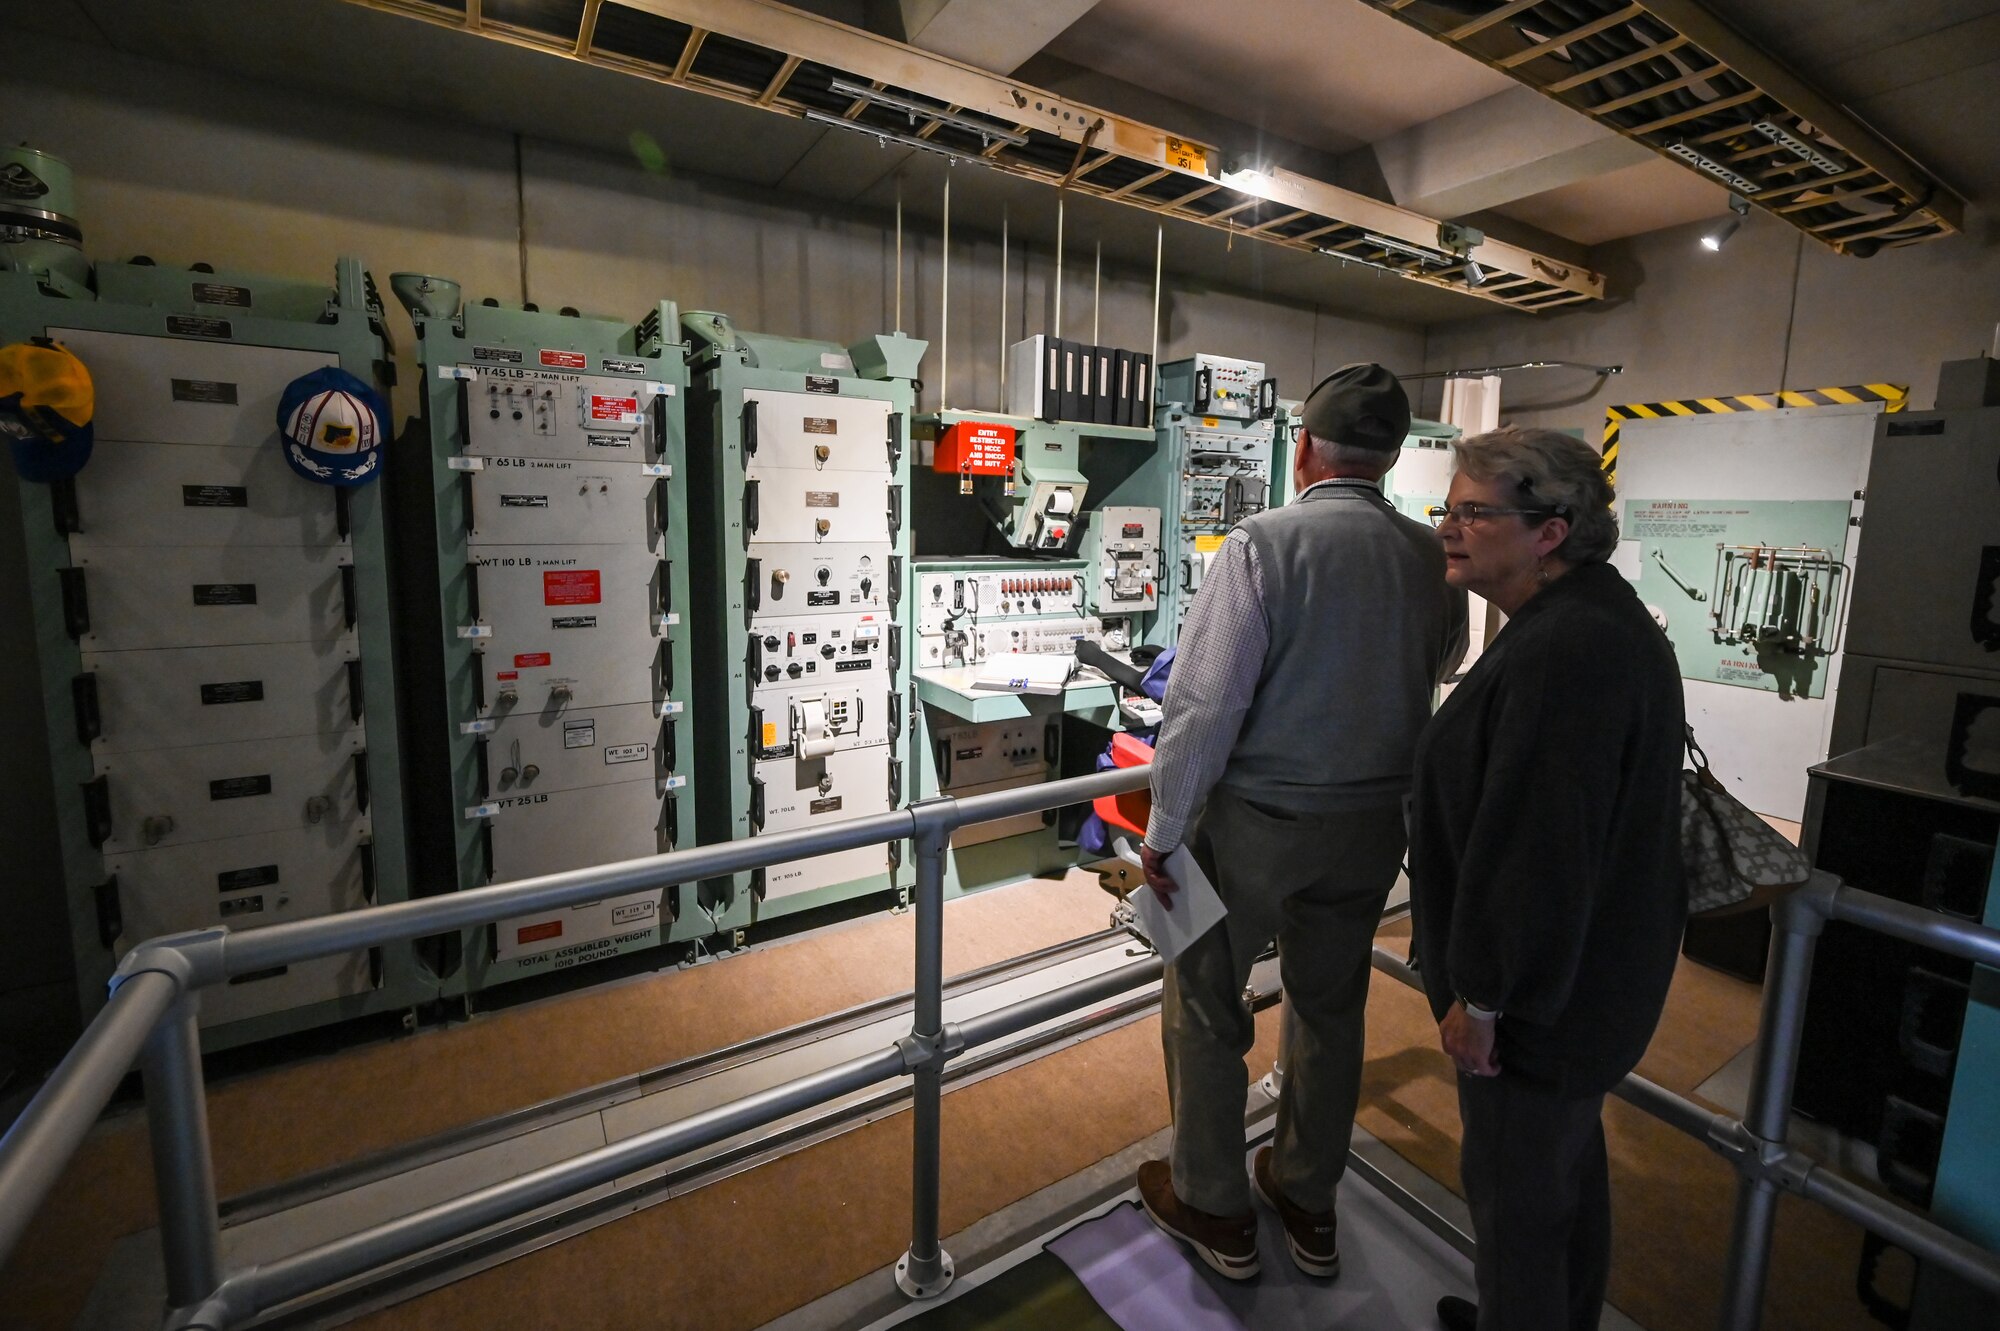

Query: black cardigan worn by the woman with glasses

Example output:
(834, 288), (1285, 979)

(1410, 564), (1688, 1095)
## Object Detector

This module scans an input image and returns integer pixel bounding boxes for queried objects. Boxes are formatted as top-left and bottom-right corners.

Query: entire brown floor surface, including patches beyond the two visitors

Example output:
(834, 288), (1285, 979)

(15, 879), (1874, 1331)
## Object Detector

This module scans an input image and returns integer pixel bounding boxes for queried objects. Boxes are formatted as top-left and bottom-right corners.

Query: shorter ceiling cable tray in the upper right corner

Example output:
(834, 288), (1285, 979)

(1368, 0), (1964, 256)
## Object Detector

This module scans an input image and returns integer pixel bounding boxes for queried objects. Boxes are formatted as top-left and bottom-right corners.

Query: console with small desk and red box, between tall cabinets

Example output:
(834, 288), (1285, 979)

(910, 410), (1170, 893)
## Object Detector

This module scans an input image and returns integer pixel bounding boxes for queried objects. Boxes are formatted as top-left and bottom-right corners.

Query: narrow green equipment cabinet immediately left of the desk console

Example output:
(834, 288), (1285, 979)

(682, 314), (926, 935)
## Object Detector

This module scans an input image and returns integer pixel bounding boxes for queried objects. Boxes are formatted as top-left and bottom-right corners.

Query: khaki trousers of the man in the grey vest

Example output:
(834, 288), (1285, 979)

(1160, 789), (1404, 1215)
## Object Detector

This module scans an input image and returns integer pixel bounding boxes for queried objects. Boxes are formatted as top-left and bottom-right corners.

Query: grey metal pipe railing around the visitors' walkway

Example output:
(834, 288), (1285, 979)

(0, 767), (2000, 1331)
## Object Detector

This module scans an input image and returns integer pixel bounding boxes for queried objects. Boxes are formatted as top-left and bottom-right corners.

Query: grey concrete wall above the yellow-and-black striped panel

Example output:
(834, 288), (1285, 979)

(1422, 214), (2000, 427)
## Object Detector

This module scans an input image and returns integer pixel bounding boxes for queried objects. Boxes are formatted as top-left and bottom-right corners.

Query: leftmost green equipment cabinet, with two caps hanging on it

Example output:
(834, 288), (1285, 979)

(0, 258), (436, 1049)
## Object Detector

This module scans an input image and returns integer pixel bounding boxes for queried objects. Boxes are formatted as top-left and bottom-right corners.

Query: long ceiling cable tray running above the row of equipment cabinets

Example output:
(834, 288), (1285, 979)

(336, 0), (1604, 310)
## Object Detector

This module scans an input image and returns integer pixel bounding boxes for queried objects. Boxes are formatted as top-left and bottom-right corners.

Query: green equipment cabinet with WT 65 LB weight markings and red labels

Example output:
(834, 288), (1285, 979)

(392, 274), (694, 993)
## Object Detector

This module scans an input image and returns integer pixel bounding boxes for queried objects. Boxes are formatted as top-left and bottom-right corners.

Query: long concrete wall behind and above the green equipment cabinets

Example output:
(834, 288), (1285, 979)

(0, 38), (1424, 1063)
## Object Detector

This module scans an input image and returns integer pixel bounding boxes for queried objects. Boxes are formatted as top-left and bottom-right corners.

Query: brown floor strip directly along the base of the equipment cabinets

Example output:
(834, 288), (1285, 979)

(0, 873), (1110, 1329)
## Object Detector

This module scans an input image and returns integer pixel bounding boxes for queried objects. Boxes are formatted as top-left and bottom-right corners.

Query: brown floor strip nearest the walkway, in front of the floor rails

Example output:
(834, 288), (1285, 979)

(354, 1009), (1278, 1331)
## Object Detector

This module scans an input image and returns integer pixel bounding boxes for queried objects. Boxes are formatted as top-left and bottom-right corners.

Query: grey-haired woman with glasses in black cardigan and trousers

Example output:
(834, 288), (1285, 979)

(1410, 430), (1686, 1331)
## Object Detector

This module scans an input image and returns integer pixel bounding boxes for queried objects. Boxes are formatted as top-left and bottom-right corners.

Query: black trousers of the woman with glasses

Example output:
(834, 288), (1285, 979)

(1458, 1071), (1612, 1331)
